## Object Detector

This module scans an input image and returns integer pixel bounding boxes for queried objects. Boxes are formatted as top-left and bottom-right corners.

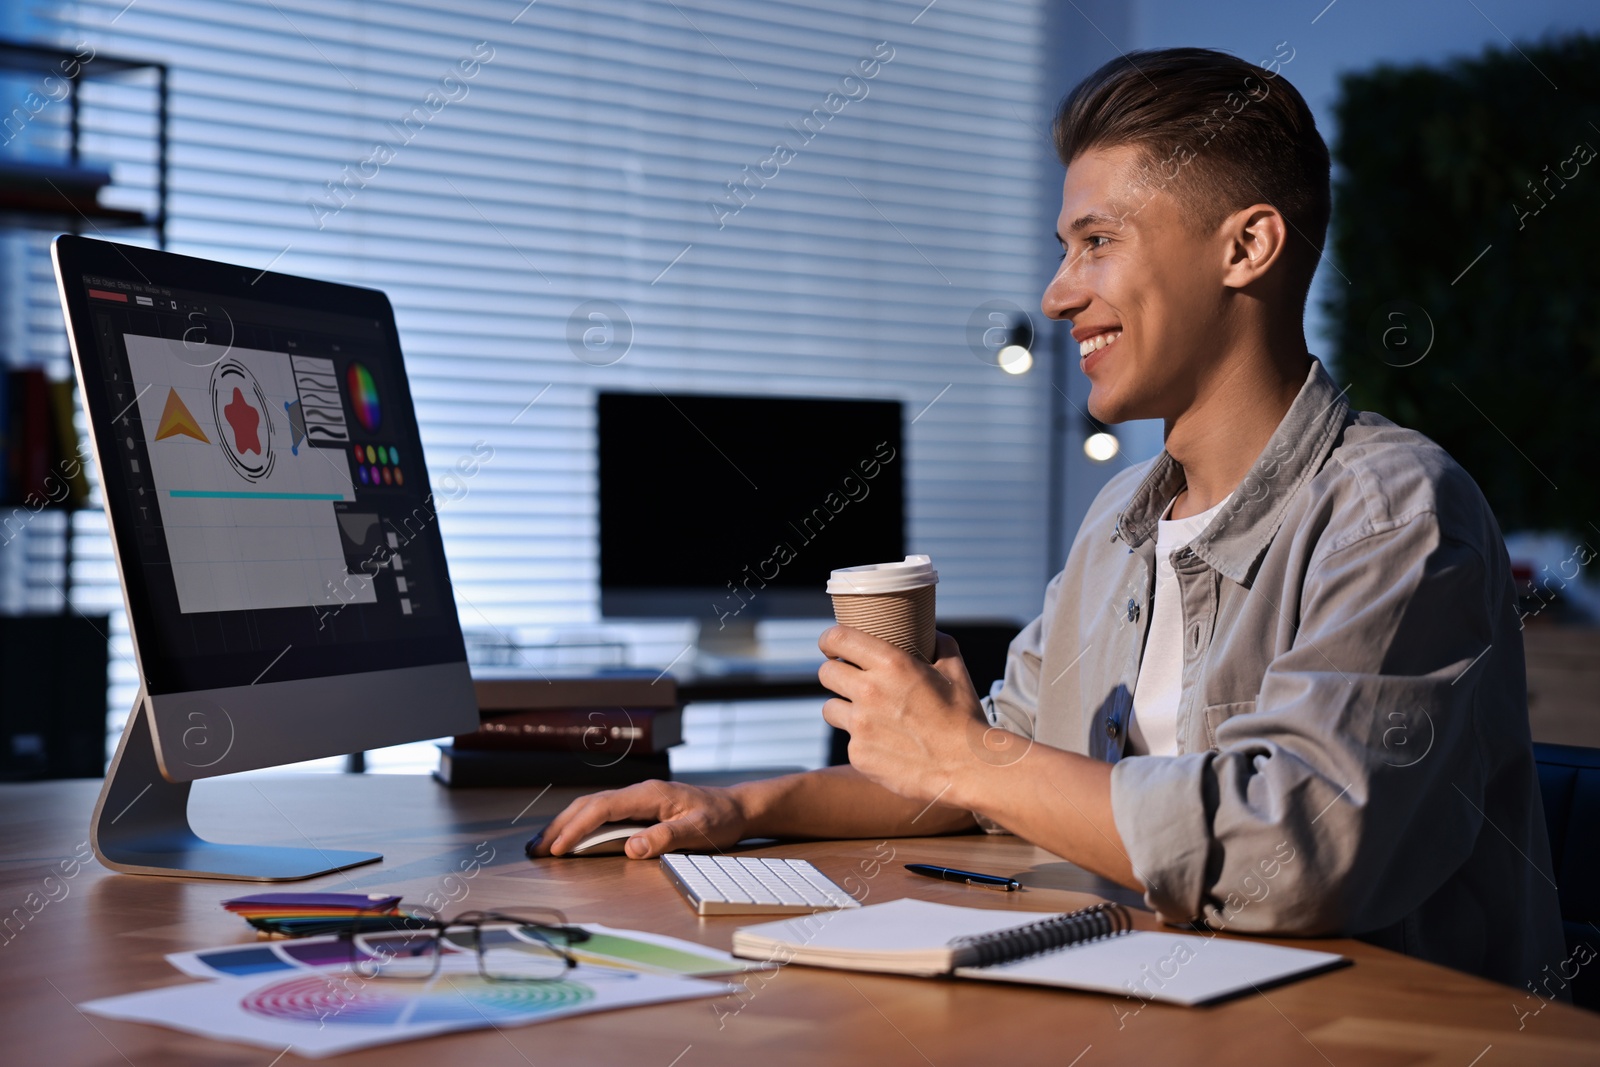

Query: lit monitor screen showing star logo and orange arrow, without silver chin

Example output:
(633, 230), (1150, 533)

(58, 238), (475, 697)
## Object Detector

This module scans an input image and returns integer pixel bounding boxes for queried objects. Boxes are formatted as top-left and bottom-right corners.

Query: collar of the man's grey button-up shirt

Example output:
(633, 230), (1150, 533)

(1115, 357), (1350, 585)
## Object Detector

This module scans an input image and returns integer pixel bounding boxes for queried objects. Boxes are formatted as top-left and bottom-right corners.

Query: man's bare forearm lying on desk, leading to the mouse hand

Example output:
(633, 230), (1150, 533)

(731, 766), (976, 838)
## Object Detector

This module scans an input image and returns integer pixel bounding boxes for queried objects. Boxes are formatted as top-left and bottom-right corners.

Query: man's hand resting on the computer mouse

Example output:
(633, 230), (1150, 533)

(531, 781), (746, 859)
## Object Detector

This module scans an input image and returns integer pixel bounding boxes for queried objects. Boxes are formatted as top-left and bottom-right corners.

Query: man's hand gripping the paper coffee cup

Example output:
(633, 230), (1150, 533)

(818, 625), (987, 803)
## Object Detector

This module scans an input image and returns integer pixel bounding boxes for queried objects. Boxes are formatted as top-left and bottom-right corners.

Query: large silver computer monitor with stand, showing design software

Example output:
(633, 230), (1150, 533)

(53, 237), (478, 881)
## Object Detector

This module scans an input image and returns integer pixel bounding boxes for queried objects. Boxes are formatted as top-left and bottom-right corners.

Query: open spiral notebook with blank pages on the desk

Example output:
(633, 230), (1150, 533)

(733, 899), (1349, 1005)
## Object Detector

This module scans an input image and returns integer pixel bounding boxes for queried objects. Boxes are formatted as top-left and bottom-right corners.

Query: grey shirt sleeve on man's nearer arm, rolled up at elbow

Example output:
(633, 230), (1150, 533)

(1112, 512), (1506, 934)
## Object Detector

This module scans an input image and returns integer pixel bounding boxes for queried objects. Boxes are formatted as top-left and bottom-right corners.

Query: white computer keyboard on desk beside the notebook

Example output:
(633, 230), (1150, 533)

(661, 853), (861, 915)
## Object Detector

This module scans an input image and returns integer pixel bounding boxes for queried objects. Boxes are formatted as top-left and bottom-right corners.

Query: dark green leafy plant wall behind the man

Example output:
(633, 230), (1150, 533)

(1323, 37), (1600, 533)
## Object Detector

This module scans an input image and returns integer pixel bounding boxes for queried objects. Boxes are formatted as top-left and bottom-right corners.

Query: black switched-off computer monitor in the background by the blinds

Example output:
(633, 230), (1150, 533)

(597, 392), (906, 656)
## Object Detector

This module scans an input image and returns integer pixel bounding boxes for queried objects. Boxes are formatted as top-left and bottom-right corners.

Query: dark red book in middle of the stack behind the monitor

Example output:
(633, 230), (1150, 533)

(454, 707), (683, 757)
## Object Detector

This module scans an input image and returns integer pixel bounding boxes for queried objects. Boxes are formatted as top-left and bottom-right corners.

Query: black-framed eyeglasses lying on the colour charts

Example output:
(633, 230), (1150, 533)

(339, 909), (589, 982)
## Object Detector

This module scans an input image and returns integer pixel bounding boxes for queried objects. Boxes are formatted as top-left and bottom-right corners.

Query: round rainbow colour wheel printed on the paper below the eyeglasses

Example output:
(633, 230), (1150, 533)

(240, 974), (595, 1025)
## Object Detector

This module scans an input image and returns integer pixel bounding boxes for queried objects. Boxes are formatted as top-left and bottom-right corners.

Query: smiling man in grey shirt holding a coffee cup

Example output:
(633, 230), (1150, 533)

(539, 48), (1565, 987)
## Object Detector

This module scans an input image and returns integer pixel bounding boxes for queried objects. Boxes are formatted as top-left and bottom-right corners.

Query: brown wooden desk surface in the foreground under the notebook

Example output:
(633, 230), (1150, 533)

(0, 774), (1600, 1067)
